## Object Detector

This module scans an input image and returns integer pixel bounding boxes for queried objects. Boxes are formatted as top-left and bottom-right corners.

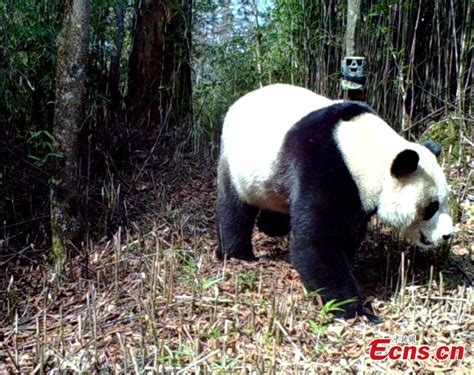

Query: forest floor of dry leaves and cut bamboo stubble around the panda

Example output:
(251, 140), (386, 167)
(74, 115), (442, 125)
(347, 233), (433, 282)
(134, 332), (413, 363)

(0, 152), (474, 373)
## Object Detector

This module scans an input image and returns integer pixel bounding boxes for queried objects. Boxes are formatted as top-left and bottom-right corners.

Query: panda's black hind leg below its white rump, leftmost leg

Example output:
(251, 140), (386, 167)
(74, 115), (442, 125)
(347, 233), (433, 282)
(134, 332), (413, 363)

(216, 162), (258, 260)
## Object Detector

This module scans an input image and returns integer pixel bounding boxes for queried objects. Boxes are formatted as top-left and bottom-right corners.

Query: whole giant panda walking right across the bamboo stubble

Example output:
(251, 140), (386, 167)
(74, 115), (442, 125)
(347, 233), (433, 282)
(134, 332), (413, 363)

(216, 84), (453, 321)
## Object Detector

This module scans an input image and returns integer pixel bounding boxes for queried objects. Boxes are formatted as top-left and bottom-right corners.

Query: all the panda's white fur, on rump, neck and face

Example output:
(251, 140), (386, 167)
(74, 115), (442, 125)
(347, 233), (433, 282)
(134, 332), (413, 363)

(221, 84), (453, 247)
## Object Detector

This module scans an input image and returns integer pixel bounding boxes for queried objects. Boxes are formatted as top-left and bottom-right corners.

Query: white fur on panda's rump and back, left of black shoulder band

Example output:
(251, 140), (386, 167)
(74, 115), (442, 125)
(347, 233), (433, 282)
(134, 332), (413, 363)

(221, 84), (333, 211)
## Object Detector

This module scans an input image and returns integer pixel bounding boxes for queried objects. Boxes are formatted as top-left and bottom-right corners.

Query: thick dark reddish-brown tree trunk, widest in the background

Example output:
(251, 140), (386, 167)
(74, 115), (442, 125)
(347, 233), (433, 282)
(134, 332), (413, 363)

(127, 0), (192, 136)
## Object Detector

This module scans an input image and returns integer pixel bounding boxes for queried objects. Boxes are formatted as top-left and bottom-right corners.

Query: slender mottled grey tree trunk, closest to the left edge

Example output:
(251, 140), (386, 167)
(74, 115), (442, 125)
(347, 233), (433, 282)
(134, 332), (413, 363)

(51, 0), (91, 264)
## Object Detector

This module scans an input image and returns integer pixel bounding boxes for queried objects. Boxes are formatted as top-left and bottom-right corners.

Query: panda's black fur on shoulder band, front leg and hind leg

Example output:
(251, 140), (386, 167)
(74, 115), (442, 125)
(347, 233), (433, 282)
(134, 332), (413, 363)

(217, 102), (382, 318)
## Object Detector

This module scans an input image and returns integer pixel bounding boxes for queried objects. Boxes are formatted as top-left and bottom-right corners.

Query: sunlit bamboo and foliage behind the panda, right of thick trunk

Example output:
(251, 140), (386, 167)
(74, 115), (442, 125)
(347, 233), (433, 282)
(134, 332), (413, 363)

(194, 0), (473, 139)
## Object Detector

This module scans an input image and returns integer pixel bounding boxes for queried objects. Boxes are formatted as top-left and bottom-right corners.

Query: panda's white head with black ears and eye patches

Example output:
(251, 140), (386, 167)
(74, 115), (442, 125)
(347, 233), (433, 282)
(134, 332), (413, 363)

(377, 141), (453, 248)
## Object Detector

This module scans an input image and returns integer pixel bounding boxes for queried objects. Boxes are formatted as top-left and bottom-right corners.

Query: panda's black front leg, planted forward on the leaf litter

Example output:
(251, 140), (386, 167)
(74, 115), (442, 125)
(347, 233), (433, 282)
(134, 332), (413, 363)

(290, 206), (378, 321)
